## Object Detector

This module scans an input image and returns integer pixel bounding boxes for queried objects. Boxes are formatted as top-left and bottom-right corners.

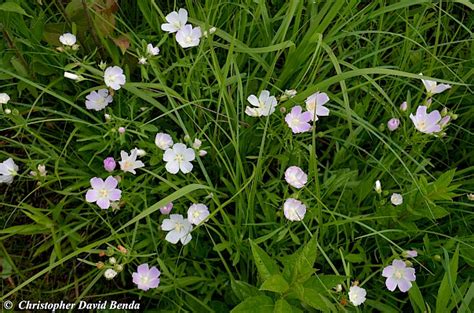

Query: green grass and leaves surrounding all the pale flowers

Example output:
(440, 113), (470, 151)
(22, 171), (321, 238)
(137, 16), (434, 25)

(0, 0), (474, 312)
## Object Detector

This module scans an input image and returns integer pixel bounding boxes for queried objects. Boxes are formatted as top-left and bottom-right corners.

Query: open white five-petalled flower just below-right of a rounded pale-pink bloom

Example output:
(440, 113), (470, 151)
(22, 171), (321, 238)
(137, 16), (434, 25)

(163, 143), (196, 174)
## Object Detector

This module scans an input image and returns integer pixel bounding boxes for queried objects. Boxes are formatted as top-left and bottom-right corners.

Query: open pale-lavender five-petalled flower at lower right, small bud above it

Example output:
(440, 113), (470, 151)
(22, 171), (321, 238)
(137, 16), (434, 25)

(382, 260), (416, 292)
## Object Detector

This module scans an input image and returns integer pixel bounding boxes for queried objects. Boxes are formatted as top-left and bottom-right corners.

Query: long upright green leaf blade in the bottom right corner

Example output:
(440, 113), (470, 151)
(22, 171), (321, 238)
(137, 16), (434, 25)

(435, 246), (459, 313)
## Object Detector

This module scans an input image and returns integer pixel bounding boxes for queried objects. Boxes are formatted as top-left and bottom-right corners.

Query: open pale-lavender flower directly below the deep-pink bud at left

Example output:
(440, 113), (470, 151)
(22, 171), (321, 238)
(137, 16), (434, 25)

(86, 176), (122, 209)
